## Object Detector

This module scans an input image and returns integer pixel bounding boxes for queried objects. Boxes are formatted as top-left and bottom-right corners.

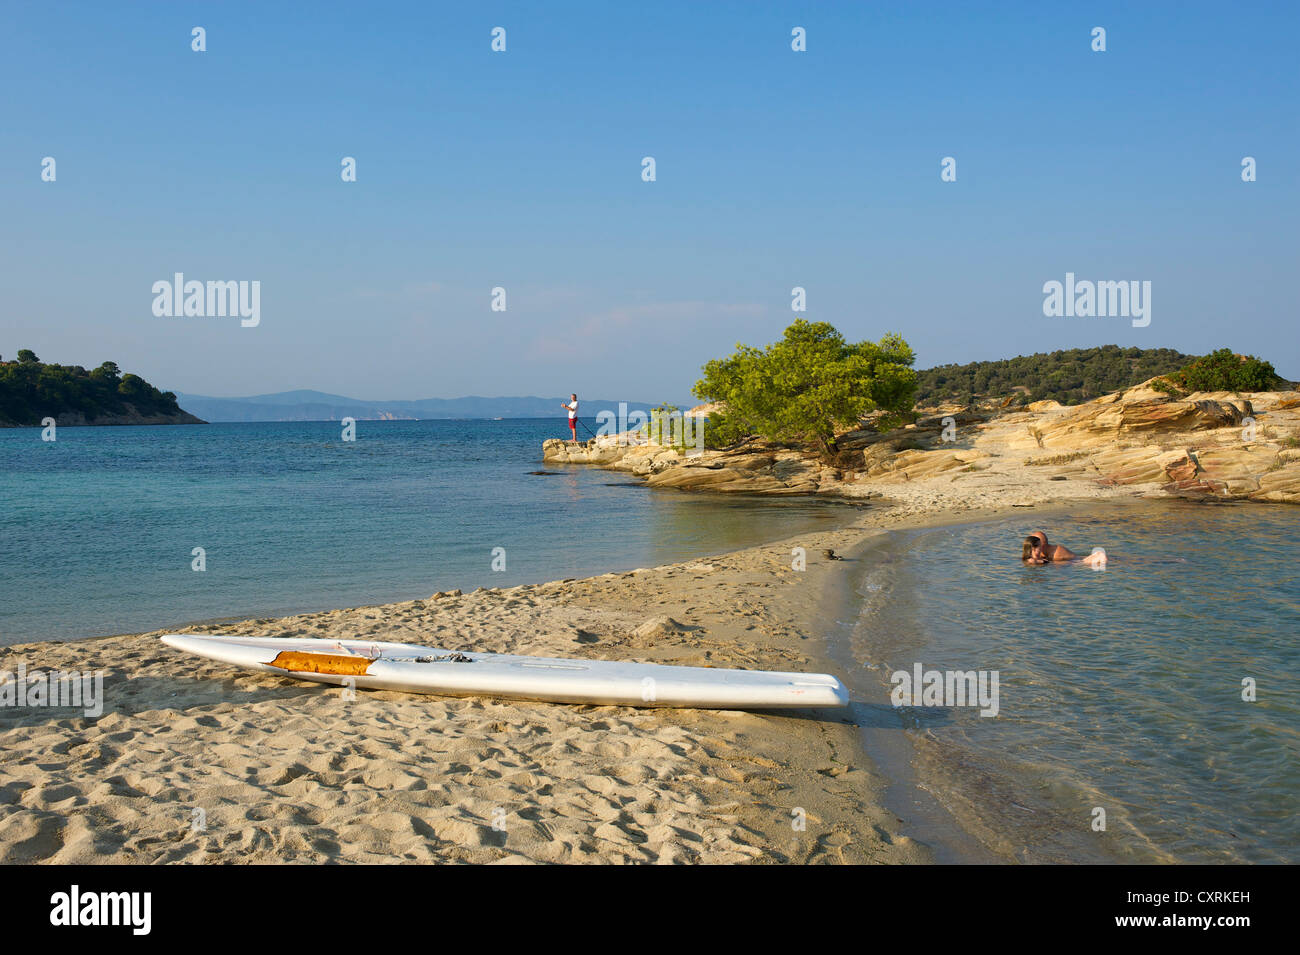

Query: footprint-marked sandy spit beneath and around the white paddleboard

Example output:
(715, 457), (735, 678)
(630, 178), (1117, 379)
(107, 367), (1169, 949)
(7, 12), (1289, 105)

(0, 462), (1134, 863)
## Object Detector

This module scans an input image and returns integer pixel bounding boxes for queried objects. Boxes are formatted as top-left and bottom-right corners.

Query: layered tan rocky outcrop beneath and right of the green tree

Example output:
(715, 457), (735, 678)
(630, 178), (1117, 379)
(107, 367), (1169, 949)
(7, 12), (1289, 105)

(543, 382), (1300, 503)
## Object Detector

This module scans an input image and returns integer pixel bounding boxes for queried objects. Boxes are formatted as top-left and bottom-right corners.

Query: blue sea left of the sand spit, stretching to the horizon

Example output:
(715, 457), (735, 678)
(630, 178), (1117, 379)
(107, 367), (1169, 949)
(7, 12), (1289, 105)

(0, 420), (853, 644)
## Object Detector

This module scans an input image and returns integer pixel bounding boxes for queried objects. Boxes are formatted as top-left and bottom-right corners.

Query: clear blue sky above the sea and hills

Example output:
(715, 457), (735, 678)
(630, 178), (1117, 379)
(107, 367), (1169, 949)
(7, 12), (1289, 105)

(0, 0), (1300, 400)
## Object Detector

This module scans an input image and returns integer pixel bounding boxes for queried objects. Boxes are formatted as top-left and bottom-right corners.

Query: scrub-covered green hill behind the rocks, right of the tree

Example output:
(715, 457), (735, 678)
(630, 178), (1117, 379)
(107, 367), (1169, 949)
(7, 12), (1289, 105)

(917, 344), (1196, 405)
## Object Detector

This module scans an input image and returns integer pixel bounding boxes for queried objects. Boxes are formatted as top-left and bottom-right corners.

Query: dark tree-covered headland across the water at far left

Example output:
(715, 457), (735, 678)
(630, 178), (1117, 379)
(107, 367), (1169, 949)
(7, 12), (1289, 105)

(0, 348), (203, 427)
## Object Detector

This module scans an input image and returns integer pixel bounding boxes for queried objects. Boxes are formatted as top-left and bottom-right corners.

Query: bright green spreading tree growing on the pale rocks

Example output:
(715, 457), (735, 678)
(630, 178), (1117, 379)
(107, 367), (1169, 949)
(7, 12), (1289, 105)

(694, 318), (917, 460)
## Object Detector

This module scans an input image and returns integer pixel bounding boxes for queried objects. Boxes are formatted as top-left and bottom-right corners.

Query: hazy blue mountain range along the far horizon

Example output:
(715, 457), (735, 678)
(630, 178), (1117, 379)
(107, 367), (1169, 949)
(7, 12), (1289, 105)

(167, 391), (690, 421)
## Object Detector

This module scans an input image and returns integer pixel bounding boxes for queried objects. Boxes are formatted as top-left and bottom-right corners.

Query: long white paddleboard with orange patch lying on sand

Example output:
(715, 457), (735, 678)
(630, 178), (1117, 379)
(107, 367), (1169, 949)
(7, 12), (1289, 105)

(163, 633), (849, 709)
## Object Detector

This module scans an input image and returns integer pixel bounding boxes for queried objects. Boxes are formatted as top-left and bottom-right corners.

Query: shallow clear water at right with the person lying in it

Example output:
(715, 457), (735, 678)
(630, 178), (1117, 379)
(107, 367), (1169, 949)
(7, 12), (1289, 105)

(849, 503), (1300, 863)
